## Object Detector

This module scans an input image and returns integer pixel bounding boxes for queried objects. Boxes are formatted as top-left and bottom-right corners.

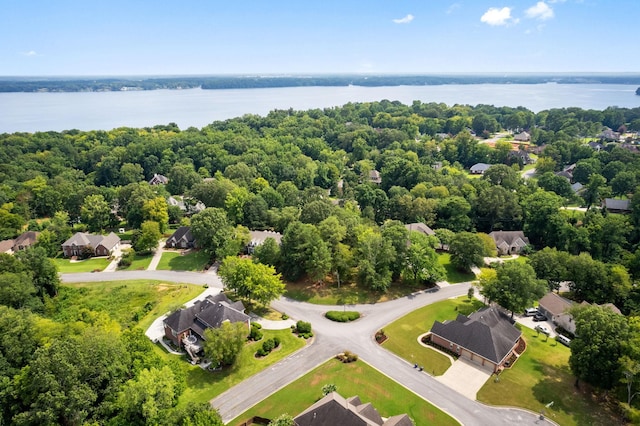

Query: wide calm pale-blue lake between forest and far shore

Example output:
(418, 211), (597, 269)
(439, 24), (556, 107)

(0, 84), (640, 133)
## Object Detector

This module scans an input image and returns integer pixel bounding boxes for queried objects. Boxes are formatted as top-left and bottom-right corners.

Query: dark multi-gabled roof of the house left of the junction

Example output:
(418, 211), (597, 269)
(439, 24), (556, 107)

(164, 293), (249, 338)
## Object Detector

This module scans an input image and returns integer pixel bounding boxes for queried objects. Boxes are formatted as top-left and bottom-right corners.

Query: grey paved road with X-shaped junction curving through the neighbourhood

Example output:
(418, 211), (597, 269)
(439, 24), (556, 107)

(62, 271), (538, 425)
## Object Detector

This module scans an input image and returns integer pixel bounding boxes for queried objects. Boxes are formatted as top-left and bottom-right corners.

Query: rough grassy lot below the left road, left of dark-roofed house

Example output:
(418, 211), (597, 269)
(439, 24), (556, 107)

(50, 280), (203, 330)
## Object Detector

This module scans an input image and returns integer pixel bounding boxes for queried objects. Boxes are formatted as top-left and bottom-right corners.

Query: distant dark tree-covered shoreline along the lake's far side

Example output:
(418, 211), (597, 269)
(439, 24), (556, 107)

(0, 74), (640, 93)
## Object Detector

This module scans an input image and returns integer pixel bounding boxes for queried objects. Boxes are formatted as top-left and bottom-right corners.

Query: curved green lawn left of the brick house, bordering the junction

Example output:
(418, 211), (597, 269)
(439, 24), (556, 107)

(382, 297), (482, 376)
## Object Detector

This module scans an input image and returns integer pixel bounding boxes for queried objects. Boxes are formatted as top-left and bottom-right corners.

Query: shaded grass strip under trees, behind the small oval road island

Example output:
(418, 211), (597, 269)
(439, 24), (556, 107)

(285, 282), (424, 305)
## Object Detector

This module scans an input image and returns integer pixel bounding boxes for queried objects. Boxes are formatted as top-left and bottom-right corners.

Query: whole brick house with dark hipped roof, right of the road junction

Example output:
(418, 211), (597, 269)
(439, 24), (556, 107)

(429, 307), (522, 373)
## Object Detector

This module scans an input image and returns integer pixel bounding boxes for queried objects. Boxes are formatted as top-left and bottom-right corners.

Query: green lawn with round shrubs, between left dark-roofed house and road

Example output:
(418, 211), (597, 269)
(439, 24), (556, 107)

(172, 329), (306, 406)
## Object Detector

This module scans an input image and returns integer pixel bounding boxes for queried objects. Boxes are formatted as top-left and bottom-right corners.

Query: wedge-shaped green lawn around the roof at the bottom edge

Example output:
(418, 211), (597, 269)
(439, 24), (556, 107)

(229, 360), (459, 426)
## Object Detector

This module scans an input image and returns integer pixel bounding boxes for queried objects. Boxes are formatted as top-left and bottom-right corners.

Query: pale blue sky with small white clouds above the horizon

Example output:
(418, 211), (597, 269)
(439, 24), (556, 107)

(0, 0), (640, 76)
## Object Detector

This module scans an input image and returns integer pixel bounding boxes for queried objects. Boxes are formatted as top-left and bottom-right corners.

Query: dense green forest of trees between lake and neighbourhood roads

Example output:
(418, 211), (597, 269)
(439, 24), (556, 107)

(0, 100), (640, 424)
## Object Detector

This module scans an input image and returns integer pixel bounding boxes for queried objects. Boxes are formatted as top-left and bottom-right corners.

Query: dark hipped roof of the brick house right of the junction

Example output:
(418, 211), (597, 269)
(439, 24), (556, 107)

(431, 307), (522, 364)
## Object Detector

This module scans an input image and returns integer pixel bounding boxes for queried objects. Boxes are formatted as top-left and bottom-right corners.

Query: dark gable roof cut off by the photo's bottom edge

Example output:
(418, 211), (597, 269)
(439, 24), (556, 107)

(294, 392), (413, 426)
